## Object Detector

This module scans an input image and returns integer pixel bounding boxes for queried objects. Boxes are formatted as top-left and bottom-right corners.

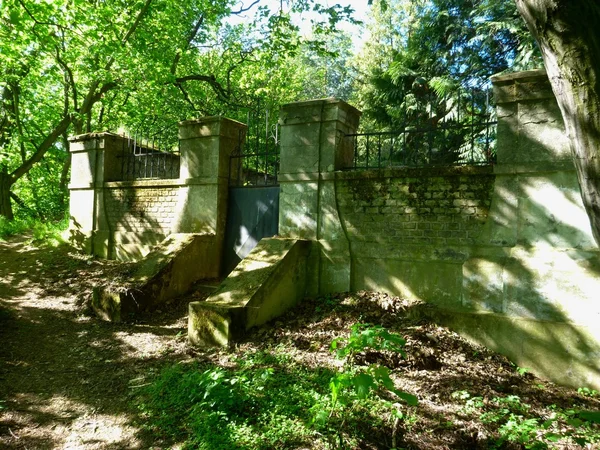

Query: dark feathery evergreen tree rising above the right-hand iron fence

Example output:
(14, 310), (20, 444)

(359, 0), (536, 128)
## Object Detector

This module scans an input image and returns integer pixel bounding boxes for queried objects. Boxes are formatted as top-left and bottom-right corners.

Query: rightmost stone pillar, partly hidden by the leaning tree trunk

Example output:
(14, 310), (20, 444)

(482, 70), (596, 248)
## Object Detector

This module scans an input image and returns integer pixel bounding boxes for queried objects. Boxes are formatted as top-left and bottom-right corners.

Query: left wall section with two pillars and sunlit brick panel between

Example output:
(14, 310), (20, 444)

(69, 117), (246, 264)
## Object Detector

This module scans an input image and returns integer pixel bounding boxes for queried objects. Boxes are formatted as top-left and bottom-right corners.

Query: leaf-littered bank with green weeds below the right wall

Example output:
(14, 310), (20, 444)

(134, 298), (600, 449)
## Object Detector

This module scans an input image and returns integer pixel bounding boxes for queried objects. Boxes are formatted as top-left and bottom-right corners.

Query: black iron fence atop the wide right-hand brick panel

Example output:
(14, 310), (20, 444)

(346, 90), (497, 169)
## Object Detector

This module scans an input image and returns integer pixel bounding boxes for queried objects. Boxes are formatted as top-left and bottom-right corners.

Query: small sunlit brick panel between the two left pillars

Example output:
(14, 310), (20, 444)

(104, 186), (179, 234)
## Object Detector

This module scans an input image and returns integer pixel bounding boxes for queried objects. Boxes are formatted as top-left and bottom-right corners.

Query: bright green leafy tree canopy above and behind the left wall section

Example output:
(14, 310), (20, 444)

(0, 0), (350, 218)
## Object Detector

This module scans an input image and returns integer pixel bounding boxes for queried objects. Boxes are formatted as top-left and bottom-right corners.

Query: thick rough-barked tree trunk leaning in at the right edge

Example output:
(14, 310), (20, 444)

(516, 0), (600, 245)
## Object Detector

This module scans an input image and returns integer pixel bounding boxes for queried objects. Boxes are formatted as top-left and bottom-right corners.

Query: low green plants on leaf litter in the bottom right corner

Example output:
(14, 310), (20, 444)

(452, 391), (600, 449)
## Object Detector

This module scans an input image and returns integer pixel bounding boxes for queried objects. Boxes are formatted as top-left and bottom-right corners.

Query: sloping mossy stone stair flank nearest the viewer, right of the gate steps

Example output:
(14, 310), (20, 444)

(188, 238), (310, 346)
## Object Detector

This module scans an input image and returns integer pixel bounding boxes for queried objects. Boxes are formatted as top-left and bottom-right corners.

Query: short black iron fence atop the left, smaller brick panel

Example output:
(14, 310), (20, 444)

(121, 136), (180, 181)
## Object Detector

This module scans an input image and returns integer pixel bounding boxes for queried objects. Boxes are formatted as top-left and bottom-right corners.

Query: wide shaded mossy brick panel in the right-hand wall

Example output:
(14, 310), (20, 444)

(337, 167), (495, 245)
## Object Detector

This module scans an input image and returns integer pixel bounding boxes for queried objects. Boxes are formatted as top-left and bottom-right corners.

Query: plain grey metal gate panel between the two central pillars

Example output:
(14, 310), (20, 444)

(223, 186), (279, 275)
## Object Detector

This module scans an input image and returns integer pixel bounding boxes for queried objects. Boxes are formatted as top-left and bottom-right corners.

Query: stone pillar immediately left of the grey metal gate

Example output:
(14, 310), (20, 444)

(172, 117), (248, 277)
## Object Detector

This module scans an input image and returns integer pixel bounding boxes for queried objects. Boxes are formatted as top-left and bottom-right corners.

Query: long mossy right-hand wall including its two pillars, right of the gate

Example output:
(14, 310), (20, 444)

(280, 71), (600, 388)
